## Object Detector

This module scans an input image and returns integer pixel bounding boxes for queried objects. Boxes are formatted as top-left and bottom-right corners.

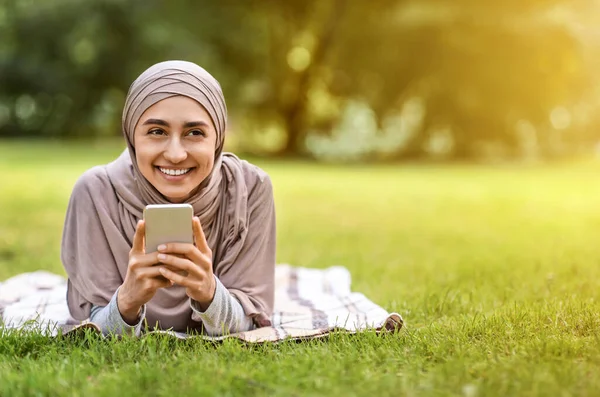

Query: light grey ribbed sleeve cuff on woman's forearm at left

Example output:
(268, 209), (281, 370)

(90, 289), (146, 336)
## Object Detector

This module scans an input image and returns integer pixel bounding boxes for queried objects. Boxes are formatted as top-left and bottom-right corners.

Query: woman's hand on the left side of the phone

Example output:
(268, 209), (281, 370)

(117, 220), (172, 324)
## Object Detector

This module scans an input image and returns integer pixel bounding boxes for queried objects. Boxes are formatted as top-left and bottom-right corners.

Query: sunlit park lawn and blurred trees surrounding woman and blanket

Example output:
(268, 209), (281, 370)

(0, 0), (600, 397)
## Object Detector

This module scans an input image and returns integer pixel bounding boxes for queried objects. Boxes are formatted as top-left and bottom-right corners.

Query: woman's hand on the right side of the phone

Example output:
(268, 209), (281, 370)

(157, 217), (216, 311)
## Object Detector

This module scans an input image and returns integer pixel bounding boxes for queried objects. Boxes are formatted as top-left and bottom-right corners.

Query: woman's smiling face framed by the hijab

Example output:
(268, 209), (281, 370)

(134, 96), (217, 203)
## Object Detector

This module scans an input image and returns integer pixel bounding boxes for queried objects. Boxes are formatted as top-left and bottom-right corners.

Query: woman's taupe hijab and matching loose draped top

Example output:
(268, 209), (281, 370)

(61, 61), (275, 331)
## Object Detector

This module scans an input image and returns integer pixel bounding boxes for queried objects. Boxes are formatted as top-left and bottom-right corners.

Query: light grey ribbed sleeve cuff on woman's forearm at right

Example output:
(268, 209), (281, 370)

(191, 277), (254, 336)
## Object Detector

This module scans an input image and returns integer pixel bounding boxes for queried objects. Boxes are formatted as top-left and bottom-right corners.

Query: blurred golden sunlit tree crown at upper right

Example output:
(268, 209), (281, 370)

(318, 0), (589, 157)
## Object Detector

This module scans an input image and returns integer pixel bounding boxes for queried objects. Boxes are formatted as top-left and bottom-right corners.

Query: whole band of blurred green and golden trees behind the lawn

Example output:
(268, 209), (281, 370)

(0, 0), (600, 162)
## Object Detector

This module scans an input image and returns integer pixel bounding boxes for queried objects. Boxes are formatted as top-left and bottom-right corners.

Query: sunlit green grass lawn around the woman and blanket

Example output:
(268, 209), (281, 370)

(0, 141), (600, 396)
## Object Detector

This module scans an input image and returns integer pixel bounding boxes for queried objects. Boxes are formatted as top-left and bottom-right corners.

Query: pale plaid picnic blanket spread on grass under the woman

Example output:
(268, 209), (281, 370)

(0, 265), (403, 343)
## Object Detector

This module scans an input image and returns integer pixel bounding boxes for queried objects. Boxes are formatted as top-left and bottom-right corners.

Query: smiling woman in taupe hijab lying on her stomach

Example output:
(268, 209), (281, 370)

(61, 61), (275, 335)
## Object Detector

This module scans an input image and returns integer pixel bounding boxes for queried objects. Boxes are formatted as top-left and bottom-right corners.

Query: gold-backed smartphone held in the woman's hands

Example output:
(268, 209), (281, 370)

(144, 204), (194, 254)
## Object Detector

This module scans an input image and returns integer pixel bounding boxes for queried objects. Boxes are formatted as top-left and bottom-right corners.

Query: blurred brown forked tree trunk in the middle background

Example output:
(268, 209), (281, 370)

(248, 0), (349, 156)
